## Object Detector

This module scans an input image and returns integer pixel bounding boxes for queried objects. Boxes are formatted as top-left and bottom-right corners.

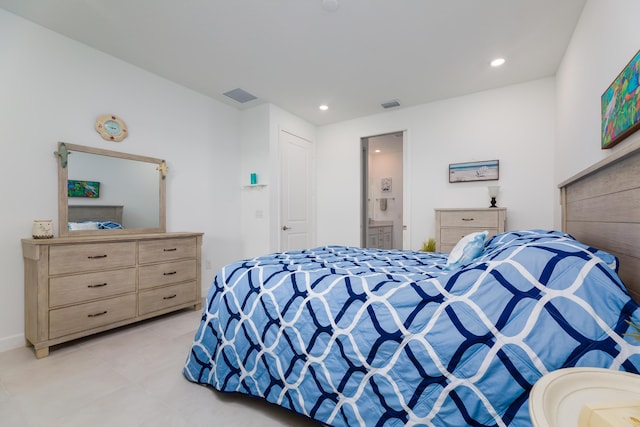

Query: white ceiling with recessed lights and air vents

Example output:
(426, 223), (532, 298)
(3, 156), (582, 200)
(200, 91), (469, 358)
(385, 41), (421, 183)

(0, 0), (586, 125)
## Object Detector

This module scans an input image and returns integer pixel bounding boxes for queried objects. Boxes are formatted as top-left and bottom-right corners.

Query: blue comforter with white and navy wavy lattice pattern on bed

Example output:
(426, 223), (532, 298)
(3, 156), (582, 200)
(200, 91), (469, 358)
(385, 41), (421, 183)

(184, 231), (640, 426)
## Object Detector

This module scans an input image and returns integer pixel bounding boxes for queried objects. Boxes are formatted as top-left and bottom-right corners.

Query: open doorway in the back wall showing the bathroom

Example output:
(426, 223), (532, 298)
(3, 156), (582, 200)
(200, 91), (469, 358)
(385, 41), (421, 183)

(361, 132), (404, 249)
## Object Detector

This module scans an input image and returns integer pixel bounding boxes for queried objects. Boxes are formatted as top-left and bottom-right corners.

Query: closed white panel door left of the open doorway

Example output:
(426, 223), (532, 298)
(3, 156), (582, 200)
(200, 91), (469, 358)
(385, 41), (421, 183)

(280, 131), (313, 251)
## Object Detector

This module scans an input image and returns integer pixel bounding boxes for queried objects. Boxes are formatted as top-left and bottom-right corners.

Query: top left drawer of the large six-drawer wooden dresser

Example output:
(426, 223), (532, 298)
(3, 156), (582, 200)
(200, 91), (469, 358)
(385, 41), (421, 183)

(49, 242), (136, 275)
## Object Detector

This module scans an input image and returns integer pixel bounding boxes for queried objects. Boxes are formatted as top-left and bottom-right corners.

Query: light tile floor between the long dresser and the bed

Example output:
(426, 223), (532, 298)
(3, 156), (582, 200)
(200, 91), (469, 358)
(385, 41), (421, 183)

(0, 310), (320, 427)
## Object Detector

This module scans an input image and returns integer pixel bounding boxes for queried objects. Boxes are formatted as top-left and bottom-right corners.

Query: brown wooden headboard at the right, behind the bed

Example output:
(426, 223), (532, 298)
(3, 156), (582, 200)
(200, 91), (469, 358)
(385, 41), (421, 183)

(559, 141), (640, 302)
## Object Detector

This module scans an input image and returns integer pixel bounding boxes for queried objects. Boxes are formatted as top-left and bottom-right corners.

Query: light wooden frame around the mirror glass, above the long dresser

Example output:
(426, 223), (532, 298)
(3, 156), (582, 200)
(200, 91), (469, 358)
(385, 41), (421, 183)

(54, 142), (167, 237)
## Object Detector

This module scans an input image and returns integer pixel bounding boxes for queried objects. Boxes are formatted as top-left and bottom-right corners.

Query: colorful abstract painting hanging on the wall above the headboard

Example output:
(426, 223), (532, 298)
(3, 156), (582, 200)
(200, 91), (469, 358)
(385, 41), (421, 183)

(601, 51), (640, 148)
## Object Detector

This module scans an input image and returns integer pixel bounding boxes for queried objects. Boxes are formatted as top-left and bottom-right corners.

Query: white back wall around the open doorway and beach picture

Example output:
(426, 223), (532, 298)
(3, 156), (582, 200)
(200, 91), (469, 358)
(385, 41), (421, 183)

(317, 78), (557, 249)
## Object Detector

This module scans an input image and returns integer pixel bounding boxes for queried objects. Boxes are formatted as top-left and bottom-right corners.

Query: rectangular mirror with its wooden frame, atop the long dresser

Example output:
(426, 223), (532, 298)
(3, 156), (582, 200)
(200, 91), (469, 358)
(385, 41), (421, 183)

(55, 142), (167, 237)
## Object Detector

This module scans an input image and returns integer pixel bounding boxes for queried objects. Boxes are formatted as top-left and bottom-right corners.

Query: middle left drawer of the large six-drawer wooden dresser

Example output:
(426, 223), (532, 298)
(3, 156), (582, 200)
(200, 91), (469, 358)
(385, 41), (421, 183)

(49, 267), (136, 307)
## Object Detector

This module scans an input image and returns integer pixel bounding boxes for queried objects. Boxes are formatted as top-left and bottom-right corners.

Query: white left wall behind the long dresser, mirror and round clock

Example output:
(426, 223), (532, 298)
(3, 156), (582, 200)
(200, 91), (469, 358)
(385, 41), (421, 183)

(0, 10), (242, 351)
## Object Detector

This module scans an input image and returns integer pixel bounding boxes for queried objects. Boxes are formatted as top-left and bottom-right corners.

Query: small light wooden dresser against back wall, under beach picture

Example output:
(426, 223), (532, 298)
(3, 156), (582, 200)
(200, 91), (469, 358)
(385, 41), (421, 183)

(435, 208), (507, 252)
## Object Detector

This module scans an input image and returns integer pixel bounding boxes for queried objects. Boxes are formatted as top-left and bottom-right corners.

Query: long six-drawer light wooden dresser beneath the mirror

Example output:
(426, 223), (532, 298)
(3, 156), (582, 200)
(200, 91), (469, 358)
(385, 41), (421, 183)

(22, 233), (202, 358)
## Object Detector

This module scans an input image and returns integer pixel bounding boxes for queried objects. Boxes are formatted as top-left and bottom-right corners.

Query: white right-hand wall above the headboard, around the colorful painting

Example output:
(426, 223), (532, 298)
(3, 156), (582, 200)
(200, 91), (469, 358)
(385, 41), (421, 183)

(555, 0), (640, 227)
